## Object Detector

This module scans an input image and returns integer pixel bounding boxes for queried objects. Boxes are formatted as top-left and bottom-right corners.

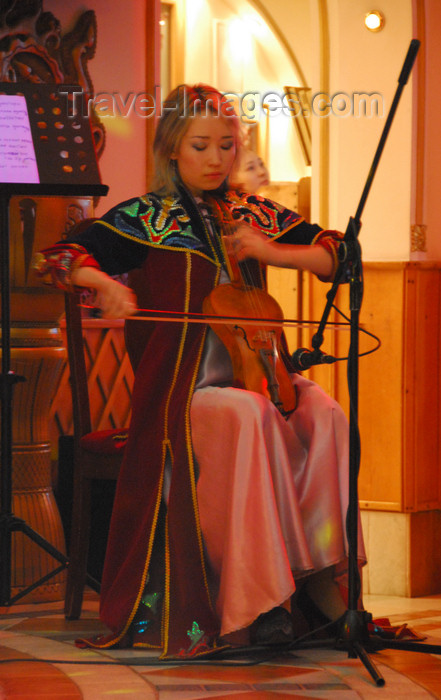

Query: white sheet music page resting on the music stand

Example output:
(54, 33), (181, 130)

(0, 95), (40, 183)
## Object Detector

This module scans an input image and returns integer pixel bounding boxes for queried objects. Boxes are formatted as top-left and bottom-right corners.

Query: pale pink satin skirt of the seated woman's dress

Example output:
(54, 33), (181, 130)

(191, 328), (365, 635)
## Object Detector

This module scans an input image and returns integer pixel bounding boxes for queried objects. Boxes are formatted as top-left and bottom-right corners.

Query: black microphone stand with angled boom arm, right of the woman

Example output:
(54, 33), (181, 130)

(294, 39), (424, 686)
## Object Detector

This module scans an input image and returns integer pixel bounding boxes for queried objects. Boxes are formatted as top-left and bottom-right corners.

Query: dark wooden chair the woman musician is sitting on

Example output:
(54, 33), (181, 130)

(64, 292), (127, 620)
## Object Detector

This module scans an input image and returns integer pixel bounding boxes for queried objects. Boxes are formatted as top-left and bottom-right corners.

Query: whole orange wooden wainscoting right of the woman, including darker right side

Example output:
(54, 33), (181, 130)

(270, 262), (441, 512)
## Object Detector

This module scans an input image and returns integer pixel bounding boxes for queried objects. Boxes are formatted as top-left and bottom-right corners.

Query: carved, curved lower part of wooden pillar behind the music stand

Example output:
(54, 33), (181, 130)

(2, 326), (66, 602)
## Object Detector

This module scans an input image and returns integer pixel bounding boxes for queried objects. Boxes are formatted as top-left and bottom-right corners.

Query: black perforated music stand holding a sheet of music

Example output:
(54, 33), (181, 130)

(0, 83), (108, 605)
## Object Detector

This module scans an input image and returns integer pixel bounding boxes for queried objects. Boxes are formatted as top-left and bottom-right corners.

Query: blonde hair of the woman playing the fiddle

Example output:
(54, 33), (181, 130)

(152, 83), (240, 195)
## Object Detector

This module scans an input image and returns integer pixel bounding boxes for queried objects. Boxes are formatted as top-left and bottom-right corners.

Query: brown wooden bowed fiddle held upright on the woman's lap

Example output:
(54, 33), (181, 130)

(202, 197), (296, 417)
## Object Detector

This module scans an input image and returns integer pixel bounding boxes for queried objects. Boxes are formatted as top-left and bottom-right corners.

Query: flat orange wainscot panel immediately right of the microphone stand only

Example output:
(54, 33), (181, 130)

(359, 263), (404, 511)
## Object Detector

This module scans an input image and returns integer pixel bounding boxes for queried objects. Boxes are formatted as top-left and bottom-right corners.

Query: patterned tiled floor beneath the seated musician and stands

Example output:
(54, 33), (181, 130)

(0, 594), (441, 700)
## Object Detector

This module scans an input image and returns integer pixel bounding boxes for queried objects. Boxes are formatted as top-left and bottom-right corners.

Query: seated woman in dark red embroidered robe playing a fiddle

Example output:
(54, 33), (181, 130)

(36, 85), (364, 657)
